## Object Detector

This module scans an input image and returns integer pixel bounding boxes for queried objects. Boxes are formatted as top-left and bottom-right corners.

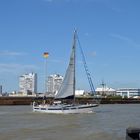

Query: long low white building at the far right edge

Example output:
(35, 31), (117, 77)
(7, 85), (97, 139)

(116, 88), (140, 98)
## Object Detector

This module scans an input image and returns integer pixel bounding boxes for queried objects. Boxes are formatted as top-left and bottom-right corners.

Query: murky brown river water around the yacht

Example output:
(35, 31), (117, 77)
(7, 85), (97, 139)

(0, 104), (140, 140)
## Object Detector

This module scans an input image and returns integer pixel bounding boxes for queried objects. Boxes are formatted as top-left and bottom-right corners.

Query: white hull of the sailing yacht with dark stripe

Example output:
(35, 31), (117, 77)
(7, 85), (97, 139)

(33, 104), (98, 114)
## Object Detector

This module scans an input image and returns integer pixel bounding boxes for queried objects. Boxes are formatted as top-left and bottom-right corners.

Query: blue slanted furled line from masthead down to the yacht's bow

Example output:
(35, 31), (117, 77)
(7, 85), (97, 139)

(77, 34), (95, 95)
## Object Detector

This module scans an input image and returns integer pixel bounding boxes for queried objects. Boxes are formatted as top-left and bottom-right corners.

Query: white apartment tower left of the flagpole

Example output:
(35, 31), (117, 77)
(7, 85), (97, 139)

(19, 73), (37, 95)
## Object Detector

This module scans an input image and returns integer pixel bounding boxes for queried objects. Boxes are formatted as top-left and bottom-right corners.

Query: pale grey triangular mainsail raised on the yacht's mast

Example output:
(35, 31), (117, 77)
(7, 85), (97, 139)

(55, 31), (76, 98)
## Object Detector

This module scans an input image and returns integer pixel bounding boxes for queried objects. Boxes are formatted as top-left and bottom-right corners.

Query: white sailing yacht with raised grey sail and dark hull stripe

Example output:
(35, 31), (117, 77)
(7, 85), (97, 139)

(33, 31), (98, 114)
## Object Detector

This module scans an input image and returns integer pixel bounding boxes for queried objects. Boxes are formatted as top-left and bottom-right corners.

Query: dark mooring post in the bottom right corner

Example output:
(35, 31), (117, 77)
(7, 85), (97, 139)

(126, 127), (140, 140)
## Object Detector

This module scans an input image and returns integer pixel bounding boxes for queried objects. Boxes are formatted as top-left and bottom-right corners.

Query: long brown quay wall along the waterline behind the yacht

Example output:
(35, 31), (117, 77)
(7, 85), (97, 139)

(0, 97), (140, 105)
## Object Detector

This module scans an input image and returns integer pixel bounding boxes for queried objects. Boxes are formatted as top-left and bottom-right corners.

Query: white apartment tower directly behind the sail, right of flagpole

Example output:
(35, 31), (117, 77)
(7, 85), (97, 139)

(47, 74), (63, 94)
